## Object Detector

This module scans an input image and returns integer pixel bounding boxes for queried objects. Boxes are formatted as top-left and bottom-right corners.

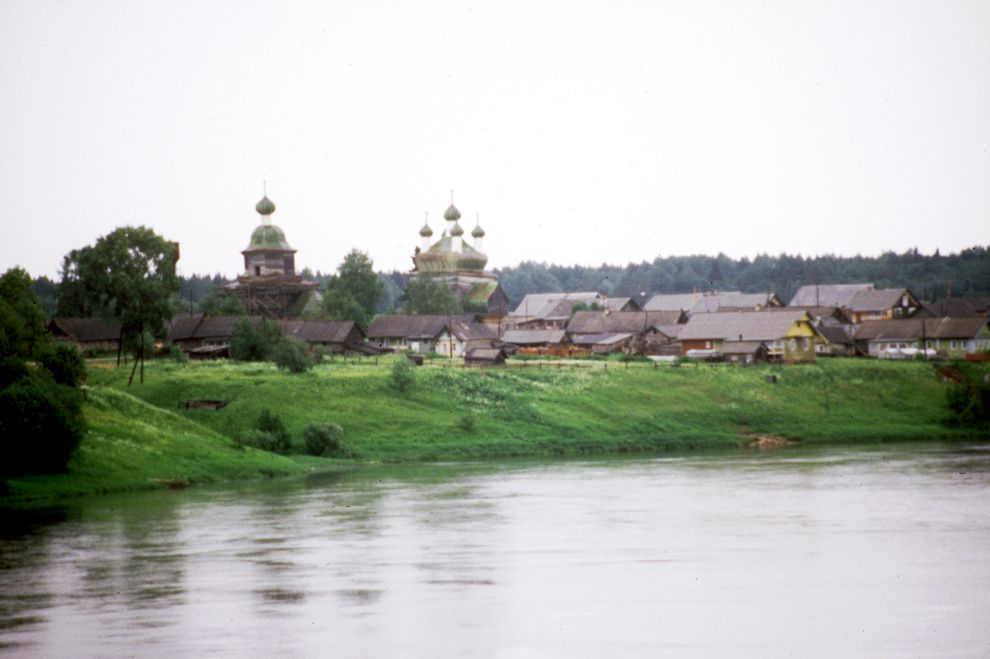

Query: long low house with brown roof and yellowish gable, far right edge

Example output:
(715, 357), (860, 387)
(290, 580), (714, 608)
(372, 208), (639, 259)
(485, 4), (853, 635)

(854, 316), (990, 359)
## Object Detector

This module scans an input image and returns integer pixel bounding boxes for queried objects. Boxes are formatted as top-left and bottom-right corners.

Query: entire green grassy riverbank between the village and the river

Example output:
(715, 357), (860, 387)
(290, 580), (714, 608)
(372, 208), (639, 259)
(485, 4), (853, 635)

(8, 359), (979, 506)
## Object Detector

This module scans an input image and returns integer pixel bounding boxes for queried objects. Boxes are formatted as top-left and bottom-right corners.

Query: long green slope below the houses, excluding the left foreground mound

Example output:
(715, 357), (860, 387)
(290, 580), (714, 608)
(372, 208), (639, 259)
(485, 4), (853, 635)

(83, 359), (974, 461)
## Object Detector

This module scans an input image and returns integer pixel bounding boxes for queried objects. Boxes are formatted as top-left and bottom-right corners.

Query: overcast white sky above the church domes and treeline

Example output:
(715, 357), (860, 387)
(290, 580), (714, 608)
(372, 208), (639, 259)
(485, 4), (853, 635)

(0, 0), (990, 276)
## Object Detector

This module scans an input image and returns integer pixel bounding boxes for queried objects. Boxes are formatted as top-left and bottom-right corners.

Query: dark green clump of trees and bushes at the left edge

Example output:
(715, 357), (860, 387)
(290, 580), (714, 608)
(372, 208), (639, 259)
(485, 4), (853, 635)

(0, 268), (86, 477)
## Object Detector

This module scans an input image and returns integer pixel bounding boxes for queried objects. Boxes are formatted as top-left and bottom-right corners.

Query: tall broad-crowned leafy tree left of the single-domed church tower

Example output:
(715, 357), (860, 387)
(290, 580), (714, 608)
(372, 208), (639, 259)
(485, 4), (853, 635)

(58, 227), (179, 360)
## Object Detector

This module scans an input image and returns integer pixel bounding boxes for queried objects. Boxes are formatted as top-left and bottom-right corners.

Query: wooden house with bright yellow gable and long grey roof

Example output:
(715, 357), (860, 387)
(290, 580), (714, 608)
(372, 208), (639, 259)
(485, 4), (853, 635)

(679, 309), (823, 363)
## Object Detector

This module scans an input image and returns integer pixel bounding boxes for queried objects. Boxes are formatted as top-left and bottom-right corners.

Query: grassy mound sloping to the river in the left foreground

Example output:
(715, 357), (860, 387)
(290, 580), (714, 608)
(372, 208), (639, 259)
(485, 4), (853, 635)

(4, 387), (306, 502)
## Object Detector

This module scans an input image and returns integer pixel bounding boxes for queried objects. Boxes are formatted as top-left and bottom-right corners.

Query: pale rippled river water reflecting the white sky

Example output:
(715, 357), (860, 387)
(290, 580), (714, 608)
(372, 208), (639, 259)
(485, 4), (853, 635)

(0, 445), (990, 658)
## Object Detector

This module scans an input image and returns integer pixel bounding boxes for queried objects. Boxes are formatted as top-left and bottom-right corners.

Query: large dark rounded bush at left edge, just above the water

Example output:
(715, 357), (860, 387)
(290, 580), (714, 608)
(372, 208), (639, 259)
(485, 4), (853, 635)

(0, 376), (85, 477)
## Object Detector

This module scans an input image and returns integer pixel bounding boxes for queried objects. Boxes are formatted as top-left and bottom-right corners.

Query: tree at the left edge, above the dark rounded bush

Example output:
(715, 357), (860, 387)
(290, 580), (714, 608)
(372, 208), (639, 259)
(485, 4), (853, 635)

(0, 268), (47, 359)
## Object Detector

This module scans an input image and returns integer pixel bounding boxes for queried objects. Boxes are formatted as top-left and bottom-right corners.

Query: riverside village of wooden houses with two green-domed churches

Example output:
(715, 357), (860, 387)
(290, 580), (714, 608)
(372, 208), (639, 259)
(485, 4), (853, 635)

(47, 195), (990, 366)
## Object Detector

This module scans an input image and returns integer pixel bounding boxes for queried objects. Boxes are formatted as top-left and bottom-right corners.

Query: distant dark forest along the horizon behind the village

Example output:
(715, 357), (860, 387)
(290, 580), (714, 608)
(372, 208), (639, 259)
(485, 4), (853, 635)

(35, 247), (990, 315)
